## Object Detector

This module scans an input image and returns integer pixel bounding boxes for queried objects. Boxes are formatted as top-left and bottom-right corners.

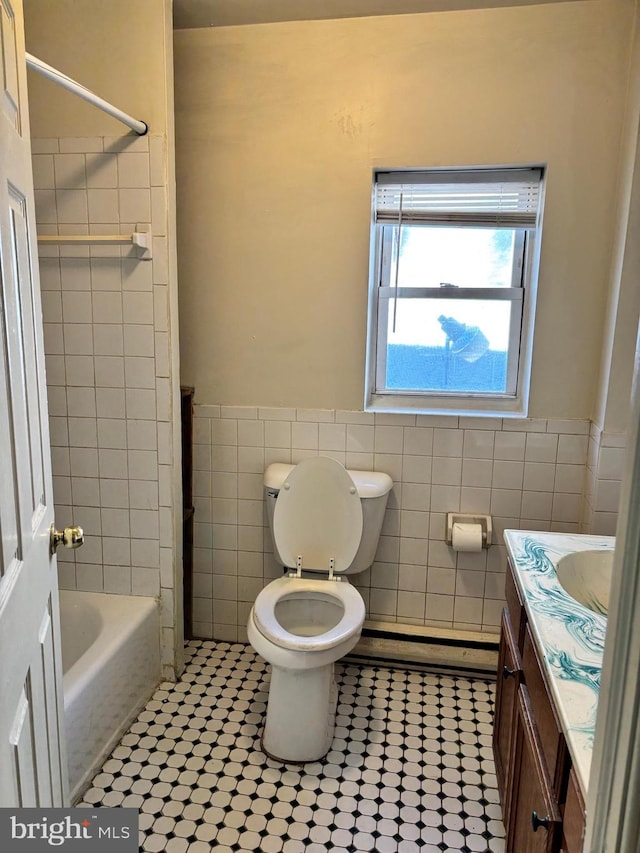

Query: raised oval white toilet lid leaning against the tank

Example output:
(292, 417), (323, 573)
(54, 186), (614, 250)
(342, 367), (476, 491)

(273, 456), (362, 572)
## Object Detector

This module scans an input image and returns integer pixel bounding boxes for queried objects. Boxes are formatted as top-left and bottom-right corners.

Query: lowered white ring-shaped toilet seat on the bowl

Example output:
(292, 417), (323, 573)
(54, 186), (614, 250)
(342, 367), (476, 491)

(253, 576), (365, 652)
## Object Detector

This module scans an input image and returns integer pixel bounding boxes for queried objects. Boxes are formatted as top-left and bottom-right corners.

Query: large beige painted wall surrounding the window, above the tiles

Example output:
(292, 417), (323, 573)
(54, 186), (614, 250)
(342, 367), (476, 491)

(175, 0), (634, 418)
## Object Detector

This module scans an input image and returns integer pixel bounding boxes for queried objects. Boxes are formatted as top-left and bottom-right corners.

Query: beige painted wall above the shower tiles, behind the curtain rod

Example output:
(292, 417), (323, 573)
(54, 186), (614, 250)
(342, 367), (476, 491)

(24, 0), (173, 137)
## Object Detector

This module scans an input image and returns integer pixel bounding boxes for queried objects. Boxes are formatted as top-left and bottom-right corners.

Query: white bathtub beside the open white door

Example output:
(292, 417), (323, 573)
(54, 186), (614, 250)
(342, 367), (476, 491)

(60, 590), (161, 803)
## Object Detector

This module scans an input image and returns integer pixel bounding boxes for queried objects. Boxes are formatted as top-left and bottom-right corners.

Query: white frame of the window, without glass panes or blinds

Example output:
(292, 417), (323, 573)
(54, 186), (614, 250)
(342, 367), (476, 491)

(364, 165), (544, 417)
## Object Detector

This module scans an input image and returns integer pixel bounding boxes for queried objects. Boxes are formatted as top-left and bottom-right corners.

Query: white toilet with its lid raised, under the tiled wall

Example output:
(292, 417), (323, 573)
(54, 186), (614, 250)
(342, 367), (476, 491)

(247, 456), (393, 763)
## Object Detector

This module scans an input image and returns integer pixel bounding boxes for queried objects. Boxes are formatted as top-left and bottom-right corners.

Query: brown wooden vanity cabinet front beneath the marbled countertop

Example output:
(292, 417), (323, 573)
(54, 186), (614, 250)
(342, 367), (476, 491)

(493, 565), (584, 853)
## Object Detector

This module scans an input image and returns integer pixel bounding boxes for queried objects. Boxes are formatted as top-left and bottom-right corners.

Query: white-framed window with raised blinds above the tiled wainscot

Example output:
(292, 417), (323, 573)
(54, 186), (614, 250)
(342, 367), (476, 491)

(365, 168), (542, 415)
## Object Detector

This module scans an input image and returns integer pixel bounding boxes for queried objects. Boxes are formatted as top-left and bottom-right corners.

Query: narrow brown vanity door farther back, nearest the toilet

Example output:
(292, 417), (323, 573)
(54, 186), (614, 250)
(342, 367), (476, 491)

(493, 608), (522, 826)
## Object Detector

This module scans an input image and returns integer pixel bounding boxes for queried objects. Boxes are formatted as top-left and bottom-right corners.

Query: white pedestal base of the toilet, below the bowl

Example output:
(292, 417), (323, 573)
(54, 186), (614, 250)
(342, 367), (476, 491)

(262, 663), (338, 764)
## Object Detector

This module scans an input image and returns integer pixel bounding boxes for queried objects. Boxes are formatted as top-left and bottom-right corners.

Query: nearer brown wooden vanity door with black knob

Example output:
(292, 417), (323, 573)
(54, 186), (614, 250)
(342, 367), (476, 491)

(507, 684), (561, 853)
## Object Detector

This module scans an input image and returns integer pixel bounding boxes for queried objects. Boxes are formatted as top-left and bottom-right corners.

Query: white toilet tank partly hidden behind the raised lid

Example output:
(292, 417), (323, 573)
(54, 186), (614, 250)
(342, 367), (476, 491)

(264, 462), (393, 575)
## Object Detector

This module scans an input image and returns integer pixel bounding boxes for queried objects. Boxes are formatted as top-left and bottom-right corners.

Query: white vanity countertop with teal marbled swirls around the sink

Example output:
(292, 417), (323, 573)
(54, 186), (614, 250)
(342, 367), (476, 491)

(504, 530), (615, 795)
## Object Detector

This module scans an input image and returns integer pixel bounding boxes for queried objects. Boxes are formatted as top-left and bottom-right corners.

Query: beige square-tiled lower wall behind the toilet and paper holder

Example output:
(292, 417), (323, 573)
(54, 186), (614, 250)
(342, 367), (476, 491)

(193, 405), (615, 640)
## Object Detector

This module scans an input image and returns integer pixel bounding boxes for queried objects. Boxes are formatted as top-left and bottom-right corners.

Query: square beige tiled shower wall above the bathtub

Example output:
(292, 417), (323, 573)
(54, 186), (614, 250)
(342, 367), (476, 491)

(32, 136), (174, 673)
